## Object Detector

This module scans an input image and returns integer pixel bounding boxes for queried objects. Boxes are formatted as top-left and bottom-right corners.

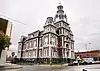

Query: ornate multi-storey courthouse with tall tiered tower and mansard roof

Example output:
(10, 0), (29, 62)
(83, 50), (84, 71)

(18, 5), (75, 63)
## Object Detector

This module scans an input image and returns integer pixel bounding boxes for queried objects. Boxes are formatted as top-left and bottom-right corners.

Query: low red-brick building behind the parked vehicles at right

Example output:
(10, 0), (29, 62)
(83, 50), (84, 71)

(75, 50), (100, 61)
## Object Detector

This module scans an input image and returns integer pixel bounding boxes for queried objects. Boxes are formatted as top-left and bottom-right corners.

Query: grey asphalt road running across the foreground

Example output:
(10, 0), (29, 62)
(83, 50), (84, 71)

(2, 64), (100, 71)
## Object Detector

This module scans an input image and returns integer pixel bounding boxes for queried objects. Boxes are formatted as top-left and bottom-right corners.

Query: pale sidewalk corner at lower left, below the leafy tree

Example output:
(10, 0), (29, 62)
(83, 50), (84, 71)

(0, 63), (23, 70)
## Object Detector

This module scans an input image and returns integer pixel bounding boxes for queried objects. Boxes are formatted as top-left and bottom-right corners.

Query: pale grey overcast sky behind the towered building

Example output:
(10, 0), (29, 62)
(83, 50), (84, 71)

(0, 0), (100, 54)
